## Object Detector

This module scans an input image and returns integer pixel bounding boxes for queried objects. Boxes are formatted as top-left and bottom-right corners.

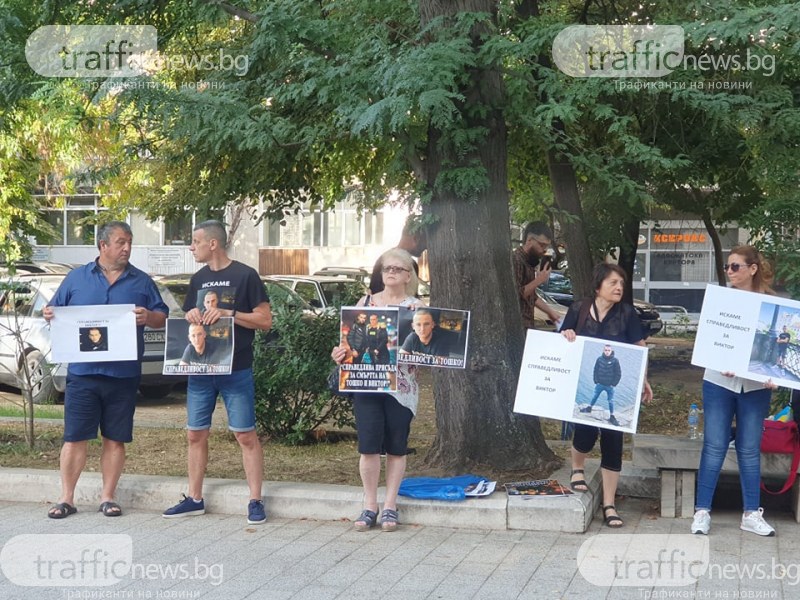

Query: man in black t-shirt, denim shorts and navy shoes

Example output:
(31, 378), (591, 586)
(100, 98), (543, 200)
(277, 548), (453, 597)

(163, 221), (272, 524)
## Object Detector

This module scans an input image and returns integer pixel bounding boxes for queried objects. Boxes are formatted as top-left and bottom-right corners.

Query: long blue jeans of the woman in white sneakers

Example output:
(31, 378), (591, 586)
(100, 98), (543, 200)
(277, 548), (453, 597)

(695, 381), (772, 511)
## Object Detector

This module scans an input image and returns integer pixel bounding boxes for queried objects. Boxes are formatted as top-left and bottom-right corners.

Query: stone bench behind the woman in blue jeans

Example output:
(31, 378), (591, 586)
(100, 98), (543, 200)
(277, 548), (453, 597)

(633, 434), (800, 523)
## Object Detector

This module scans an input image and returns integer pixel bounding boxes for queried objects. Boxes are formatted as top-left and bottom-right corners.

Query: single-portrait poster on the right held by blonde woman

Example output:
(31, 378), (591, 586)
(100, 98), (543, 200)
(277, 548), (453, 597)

(397, 306), (469, 369)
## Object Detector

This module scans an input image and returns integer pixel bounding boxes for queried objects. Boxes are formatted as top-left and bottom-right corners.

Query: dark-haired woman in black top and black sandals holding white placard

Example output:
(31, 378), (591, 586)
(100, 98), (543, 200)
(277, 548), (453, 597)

(561, 263), (653, 527)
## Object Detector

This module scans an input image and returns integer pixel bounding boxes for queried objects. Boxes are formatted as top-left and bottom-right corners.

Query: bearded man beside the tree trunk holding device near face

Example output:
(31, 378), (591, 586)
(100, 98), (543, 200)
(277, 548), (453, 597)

(512, 221), (560, 329)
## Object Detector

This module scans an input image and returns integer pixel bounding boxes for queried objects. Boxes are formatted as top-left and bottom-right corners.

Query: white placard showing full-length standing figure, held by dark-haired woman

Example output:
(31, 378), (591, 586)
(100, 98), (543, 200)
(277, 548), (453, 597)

(514, 329), (647, 433)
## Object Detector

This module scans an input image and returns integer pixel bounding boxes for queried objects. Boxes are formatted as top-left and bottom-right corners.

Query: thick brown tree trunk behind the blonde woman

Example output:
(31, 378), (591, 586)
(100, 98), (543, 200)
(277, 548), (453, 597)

(420, 0), (559, 474)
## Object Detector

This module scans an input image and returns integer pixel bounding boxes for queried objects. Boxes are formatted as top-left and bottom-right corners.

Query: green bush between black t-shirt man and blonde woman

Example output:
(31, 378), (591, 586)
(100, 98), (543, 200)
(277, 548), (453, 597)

(253, 305), (354, 444)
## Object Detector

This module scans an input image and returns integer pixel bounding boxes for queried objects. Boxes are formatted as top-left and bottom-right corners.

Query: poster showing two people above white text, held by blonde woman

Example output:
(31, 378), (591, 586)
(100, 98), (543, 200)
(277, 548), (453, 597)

(339, 306), (398, 392)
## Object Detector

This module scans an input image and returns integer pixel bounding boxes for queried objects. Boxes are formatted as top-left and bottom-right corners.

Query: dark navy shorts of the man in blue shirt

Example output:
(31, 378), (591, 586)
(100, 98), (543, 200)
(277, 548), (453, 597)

(64, 374), (140, 443)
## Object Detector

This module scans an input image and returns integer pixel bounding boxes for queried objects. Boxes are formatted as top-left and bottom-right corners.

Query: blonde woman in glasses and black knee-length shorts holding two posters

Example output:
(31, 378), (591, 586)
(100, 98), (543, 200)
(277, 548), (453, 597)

(331, 248), (423, 531)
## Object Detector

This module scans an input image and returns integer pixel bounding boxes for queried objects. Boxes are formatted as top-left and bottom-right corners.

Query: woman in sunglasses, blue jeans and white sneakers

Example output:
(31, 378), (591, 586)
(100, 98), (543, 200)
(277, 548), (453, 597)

(691, 246), (777, 536)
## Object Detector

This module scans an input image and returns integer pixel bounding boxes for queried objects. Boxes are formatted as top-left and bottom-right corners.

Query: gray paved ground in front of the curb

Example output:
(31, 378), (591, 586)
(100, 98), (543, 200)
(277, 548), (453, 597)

(0, 498), (800, 600)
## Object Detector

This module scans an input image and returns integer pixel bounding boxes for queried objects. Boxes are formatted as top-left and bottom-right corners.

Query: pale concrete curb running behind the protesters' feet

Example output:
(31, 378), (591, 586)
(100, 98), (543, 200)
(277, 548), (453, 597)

(0, 460), (601, 533)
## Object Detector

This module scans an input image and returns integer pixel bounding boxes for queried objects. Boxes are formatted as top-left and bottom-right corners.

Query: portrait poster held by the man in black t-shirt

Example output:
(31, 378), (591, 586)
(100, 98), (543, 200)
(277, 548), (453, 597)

(162, 317), (233, 375)
